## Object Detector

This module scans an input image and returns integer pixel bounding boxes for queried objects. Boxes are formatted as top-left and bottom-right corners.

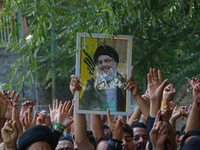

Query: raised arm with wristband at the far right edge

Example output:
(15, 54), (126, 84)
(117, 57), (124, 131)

(186, 77), (200, 132)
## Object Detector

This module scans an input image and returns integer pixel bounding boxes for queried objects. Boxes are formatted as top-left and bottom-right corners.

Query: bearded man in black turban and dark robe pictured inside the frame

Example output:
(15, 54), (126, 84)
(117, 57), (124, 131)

(79, 45), (126, 111)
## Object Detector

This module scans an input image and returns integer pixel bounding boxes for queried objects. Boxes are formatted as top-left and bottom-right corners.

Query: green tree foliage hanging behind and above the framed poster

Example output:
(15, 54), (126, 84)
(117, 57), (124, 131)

(0, 0), (200, 100)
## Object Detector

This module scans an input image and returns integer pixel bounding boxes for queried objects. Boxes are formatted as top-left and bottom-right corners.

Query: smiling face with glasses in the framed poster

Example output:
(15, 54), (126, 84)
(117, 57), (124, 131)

(98, 55), (117, 74)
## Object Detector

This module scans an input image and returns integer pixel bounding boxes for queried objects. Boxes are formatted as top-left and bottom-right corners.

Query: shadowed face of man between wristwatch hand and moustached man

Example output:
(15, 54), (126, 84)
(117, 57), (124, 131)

(122, 131), (134, 150)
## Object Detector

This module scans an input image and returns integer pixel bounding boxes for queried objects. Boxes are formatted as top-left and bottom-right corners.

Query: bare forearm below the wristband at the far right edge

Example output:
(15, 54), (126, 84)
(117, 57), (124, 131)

(186, 102), (200, 132)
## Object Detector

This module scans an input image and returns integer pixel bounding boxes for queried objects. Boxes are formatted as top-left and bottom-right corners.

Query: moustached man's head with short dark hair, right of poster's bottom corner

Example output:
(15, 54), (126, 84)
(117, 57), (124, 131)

(131, 122), (147, 150)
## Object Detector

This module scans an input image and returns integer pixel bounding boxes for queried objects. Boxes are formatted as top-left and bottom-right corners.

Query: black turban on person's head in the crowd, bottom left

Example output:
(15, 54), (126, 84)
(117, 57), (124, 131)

(18, 125), (57, 150)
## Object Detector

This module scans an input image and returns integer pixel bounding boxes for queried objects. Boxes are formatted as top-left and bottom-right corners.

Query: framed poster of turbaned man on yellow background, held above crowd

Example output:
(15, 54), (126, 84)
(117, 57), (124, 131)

(74, 33), (132, 115)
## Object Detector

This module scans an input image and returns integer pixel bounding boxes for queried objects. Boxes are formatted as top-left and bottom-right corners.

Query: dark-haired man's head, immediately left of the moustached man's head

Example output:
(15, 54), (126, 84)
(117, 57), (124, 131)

(122, 124), (134, 150)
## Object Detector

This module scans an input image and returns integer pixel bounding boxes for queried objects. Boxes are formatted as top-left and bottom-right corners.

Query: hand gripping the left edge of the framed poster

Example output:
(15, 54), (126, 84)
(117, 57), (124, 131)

(69, 75), (82, 95)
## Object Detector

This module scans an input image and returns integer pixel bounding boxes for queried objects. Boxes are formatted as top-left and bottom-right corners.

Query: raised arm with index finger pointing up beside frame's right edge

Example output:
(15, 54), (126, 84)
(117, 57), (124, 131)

(125, 67), (149, 118)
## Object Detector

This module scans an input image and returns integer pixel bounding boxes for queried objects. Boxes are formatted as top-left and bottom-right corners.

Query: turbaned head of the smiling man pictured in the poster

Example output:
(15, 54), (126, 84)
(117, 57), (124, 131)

(94, 45), (119, 76)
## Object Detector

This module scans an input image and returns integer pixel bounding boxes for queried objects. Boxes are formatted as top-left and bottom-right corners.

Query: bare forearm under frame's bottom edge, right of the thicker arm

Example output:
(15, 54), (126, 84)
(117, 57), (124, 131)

(91, 115), (104, 140)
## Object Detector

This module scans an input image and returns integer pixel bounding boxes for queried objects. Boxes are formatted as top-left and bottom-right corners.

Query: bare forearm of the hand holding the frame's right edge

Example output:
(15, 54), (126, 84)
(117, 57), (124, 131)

(133, 95), (150, 119)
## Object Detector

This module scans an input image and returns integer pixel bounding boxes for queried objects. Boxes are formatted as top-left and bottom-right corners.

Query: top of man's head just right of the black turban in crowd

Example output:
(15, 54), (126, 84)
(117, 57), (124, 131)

(56, 135), (74, 150)
